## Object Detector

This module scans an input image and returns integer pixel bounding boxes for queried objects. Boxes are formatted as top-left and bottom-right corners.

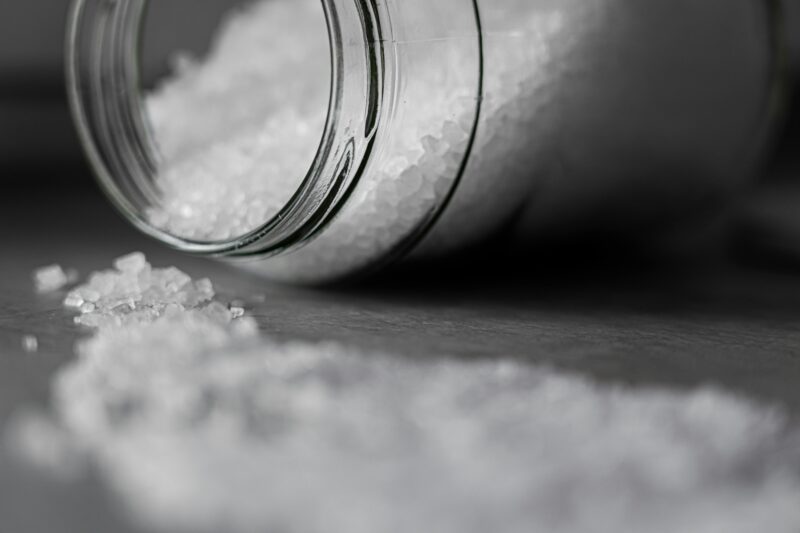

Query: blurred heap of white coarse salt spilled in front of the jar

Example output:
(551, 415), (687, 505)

(11, 254), (800, 533)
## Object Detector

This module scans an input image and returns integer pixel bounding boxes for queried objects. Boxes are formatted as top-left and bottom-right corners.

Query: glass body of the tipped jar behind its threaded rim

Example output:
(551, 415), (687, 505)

(69, 0), (777, 283)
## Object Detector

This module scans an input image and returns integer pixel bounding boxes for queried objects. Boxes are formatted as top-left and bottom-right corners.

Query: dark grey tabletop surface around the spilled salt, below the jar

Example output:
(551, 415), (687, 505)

(0, 185), (800, 533)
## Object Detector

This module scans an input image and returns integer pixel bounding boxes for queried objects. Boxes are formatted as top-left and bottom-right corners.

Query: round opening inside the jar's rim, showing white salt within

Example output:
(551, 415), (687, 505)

(137, 0), (331, 242)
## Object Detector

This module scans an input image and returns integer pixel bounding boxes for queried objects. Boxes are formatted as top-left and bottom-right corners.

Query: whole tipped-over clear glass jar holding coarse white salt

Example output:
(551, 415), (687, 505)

(68, 0), (784, 283)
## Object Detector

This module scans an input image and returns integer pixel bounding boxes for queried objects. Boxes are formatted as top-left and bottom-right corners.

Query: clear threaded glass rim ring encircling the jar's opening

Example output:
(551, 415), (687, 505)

(67, 0), (384, 256)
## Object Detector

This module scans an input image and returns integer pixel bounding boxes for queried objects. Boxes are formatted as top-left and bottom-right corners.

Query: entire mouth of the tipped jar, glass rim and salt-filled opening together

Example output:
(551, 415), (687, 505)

(67, 0), (384, 256)
